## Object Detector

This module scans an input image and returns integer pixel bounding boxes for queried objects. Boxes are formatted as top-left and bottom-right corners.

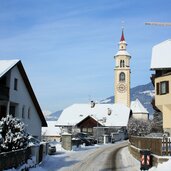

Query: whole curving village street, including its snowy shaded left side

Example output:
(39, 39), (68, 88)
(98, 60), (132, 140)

(31, 141), (140, 171)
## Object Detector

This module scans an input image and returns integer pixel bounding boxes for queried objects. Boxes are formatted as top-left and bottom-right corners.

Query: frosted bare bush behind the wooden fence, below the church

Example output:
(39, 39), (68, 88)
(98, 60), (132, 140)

(128, 118), (151, 136)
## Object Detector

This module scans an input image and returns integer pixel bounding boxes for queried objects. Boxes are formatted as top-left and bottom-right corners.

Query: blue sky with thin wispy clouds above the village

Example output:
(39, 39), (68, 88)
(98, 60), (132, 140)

(0, 0), (171, 112)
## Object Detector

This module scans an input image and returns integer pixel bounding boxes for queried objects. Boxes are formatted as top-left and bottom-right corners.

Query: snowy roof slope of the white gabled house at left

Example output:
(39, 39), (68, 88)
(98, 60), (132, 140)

(0, 59), (19, 77)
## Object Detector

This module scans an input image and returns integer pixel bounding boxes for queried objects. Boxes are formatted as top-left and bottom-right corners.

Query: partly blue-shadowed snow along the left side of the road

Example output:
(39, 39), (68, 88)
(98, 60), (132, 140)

(30, 143), (99, 171)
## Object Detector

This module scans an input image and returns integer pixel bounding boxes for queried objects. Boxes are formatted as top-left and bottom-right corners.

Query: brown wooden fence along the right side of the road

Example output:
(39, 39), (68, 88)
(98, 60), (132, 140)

(129, 136), (171, 156)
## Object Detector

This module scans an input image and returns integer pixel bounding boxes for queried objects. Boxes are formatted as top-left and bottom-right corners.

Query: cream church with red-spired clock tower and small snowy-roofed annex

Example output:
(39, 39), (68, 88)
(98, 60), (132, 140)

(114, 29), (149, 120)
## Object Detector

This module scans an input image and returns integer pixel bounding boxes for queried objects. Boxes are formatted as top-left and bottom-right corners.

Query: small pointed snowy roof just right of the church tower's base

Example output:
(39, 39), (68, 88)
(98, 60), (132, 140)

(131, 99), (148, 114)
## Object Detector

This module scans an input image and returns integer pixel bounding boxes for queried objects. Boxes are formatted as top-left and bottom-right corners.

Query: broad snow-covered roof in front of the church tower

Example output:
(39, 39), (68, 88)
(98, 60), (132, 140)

(56, 103), (130, 126)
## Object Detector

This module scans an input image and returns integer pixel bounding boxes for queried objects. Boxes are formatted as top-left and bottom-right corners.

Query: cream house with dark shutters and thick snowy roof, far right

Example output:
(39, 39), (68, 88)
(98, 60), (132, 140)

(151, 39), (171, 135)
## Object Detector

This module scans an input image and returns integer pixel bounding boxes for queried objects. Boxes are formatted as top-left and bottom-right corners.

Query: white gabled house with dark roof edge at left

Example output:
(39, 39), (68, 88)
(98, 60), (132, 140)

(0, 60), (47, 139)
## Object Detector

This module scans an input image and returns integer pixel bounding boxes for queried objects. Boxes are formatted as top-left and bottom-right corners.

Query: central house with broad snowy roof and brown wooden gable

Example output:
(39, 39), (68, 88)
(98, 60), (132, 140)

(56, 103), (130, 134)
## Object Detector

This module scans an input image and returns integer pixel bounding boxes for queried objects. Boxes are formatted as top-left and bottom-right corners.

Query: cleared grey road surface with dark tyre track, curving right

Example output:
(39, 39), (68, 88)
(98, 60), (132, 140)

(69, 141), (139, 171)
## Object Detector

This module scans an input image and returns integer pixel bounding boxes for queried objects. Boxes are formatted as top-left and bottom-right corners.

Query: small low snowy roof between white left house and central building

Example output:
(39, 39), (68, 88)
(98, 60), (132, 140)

(42, 121), (61, 136)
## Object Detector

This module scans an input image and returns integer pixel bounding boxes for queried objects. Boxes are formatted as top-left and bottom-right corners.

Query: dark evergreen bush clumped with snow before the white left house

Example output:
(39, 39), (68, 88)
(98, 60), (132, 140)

(0, 115), (28, 152)
